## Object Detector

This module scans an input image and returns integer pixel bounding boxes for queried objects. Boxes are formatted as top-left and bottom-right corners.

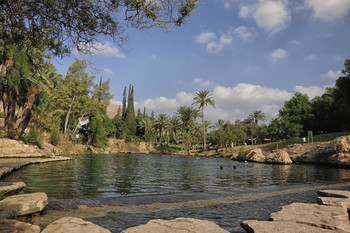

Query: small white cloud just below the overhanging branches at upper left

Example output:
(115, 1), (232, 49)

(73, 42), (125, 58)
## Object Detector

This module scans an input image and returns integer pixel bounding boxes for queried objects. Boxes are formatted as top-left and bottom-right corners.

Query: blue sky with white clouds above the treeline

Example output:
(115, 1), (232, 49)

(53, 0), (350, 122)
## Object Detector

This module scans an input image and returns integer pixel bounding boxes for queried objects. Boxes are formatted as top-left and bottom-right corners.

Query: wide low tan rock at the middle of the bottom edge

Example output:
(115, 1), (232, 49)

(122, 218), (228, 233)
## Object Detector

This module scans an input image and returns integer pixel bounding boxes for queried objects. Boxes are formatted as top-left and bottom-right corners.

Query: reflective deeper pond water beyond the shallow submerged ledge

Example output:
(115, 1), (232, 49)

(3, 154), (350, 199)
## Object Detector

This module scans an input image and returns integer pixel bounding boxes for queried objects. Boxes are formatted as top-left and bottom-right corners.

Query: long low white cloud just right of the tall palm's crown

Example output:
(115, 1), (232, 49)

(213, 83), (293, 107)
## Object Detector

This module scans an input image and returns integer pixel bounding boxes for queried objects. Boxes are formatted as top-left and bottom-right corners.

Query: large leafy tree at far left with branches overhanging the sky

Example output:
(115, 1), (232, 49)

(0, 0), (197, 139)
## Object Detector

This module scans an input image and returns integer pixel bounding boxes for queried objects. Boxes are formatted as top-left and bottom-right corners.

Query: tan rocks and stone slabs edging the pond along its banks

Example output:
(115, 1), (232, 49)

(0, 136), (350, 233)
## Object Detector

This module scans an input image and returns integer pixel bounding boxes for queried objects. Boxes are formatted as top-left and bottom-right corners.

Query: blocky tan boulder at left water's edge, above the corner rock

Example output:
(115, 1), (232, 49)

(0, 193), (48, 216)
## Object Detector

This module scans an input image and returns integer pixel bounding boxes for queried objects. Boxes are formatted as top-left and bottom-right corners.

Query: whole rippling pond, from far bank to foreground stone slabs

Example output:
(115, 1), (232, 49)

(3, 154), (350, 232)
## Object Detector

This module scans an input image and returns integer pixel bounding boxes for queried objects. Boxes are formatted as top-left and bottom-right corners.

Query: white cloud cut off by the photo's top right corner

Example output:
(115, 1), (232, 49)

(305, 0), (350, 21)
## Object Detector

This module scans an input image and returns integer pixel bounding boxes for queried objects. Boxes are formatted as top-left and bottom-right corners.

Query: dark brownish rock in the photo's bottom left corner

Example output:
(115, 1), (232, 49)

(0, 219), (40, 233)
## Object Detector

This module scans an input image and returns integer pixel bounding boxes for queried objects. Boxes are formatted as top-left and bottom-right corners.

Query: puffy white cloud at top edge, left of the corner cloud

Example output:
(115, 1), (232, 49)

(239, 0), (291, 31)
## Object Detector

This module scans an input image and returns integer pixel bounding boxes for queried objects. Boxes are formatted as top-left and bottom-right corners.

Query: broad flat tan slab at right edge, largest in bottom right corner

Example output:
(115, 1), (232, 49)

(270, 203), (350, 232)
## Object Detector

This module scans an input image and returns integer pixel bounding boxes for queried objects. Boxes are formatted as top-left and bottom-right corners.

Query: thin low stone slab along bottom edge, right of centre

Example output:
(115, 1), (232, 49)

(241, 220), (334, 233)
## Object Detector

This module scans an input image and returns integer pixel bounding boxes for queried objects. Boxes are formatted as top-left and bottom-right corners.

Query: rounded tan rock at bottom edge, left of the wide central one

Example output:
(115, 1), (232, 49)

(41, 217), (110, 233)
